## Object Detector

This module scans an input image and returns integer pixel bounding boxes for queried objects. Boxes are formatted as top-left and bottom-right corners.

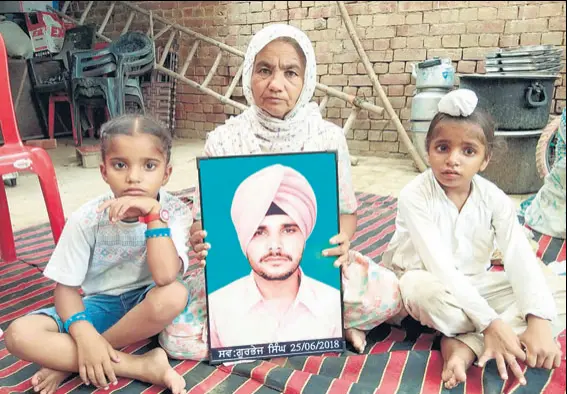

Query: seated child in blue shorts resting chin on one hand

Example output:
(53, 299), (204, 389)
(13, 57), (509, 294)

(5, 115), (192, 394)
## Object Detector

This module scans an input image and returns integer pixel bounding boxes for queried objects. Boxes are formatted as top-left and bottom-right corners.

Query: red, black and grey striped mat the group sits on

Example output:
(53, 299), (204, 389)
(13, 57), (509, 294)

(0, 190), (566, 394)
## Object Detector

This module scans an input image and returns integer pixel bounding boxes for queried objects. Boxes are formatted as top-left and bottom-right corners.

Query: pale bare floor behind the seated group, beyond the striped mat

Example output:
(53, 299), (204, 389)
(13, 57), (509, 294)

(6, 139), (524, 230)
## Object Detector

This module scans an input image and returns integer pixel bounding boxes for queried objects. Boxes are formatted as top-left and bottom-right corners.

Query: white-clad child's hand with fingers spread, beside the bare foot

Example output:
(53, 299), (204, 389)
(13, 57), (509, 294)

(478, 319), (526, 385)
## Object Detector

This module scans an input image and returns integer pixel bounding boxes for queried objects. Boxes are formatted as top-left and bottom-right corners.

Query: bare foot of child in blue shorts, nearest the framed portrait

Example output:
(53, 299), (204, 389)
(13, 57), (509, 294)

(142, 347), (187, 394)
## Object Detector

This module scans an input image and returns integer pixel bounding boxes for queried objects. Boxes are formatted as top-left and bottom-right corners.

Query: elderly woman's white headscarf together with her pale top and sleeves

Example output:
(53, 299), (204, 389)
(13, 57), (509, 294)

(194, 24), (358, 220)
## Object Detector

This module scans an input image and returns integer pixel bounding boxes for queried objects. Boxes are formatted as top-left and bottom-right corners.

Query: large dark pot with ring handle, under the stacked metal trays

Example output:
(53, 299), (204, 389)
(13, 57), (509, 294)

(460, 74), (557, 131)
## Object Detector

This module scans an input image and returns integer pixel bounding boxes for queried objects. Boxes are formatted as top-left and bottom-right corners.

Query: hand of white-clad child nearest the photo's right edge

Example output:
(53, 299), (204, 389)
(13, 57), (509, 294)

(520, 316), (562, 369)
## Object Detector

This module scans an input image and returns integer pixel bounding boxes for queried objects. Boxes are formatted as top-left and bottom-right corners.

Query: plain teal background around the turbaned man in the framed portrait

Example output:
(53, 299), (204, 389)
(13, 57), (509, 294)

(198, 152), (341, 294)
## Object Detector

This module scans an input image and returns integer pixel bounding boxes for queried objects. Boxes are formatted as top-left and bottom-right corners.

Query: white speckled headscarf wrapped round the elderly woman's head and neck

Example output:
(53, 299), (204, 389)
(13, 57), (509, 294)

(226, 24), (328, 152)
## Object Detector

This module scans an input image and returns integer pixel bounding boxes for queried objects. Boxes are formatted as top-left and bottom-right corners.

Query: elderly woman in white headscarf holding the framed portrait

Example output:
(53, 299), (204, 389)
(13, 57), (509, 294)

(160, 24), (402, 360)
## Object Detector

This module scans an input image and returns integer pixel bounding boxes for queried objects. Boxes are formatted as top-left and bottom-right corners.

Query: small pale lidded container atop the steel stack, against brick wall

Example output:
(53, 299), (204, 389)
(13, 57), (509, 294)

(411, 58), (455, 89)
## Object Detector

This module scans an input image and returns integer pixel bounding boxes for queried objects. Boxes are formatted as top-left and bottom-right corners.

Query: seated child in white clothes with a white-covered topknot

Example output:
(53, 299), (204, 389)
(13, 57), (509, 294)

(383, 89), (565, 389)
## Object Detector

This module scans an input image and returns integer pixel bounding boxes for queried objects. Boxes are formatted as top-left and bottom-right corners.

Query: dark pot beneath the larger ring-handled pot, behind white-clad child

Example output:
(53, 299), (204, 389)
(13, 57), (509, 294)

(480, 130), (543, 194)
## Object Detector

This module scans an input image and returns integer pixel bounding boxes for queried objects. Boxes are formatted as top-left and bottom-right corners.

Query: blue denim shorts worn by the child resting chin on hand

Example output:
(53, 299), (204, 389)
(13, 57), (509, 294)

(30, 283), (155, 334)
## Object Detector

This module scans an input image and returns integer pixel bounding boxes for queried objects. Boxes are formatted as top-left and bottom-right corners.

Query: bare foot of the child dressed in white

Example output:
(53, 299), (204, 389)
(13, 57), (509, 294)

(441, 337), (476, 390)
